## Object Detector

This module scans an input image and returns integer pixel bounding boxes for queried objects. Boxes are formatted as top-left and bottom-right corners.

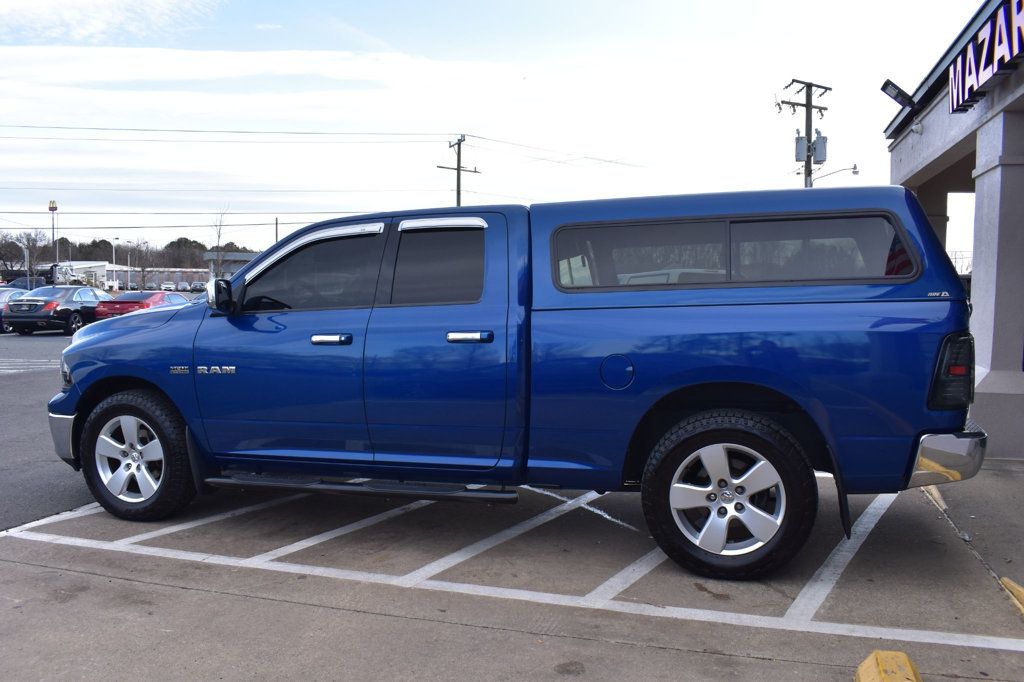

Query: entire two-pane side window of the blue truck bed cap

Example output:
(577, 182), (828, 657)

(554, 216), (913, 289)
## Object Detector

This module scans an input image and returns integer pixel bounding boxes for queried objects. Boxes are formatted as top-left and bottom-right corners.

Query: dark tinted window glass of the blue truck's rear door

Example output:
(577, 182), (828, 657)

(391, 229), (483, 304)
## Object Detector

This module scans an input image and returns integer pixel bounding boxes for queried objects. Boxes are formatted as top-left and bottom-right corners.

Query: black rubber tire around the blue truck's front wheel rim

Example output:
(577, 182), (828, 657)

(79, 390), (196, 521)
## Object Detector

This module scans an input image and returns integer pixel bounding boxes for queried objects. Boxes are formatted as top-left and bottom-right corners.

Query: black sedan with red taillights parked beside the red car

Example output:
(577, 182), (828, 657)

(4, 285), (112, 336)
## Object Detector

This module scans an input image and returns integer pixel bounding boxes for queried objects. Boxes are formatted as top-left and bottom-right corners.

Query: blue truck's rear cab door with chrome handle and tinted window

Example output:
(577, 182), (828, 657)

(365, 213), (509, 467)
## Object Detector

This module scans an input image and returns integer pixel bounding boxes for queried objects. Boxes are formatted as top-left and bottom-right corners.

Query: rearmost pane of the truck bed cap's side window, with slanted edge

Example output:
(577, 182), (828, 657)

(732, 216), (913, 282)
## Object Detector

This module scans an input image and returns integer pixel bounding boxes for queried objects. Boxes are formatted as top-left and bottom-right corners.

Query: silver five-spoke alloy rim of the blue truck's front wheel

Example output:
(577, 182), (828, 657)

(95, 415), (164, 503)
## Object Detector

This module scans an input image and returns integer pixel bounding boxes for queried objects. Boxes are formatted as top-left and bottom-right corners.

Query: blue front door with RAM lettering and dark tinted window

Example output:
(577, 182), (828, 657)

(195, 222), (385, 462)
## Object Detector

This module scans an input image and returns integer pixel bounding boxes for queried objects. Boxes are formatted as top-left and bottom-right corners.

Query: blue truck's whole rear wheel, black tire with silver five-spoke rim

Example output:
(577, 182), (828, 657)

(642, 410), (818, 580)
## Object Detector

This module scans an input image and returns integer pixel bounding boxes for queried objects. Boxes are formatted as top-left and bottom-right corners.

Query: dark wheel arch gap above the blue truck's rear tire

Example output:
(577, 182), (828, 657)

(623, 381), (840, 487)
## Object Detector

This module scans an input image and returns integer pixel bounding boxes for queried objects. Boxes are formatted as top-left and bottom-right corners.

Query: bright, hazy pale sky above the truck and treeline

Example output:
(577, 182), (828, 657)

(0, 0), (979, 250)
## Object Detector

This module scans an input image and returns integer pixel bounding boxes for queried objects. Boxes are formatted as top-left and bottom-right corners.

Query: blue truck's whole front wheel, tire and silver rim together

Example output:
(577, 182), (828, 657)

(80, 390), (196, 521)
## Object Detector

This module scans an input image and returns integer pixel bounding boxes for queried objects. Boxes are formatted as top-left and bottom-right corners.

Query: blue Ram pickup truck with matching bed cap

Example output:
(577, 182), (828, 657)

(49, 187), (986, 579)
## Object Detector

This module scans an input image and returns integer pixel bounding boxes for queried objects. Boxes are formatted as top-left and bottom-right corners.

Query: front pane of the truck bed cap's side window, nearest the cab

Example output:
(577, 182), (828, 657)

(555, 222), (728, 289)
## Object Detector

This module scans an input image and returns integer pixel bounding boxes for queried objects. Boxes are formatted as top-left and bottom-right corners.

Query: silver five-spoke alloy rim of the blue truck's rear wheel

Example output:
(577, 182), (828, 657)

(669, 442), (785, 556)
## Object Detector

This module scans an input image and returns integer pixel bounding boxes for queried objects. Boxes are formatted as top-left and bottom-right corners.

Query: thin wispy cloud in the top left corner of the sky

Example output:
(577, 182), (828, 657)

(0, 0), (218, 43)
